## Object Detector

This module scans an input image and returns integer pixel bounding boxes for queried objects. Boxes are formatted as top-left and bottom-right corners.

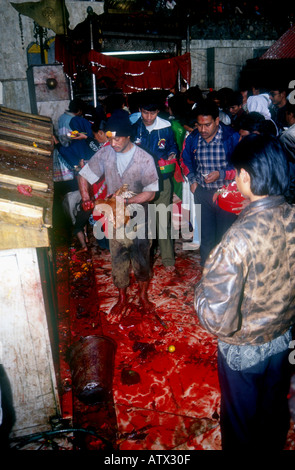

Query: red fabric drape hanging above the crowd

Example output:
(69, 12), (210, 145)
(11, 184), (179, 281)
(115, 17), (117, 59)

(84, 51), (191, 93)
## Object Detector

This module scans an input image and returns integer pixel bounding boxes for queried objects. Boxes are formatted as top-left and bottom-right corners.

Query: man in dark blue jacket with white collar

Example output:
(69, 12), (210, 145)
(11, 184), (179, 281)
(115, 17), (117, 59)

(132, 92), (178, 272)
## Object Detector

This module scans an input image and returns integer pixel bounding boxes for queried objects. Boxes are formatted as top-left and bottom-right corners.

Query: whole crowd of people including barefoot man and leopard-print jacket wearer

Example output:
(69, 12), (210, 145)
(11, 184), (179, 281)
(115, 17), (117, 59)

(56, 81), (295, 450)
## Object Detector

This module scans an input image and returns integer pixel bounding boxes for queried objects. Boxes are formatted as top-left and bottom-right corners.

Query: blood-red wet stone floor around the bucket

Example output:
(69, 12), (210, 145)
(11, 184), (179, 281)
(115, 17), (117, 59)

(57, 231), (295, 450)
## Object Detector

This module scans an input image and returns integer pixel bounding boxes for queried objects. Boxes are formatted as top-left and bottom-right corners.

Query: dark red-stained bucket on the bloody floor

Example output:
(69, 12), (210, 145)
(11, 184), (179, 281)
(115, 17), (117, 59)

(69, 335), (116, 405)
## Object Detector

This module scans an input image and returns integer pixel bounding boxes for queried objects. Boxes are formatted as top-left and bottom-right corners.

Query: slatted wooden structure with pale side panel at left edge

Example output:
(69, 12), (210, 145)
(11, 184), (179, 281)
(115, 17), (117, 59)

(0, 107), (60, 436)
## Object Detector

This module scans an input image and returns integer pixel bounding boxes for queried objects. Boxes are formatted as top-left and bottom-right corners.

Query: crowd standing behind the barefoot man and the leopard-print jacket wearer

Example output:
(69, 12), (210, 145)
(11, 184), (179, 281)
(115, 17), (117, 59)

(56, 85), (295, 258)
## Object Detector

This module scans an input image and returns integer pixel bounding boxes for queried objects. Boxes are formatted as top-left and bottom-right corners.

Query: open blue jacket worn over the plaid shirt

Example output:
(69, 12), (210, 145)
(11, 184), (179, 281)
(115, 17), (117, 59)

(182, 122), (240, 183)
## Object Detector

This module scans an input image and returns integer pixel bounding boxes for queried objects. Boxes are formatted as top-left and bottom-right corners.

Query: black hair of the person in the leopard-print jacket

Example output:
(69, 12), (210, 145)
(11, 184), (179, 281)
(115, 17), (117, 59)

(231, 134), (289, 196)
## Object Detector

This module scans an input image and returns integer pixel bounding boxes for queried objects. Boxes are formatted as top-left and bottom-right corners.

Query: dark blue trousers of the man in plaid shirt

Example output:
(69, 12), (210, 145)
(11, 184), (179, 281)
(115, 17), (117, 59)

(194, 185), (237, 266)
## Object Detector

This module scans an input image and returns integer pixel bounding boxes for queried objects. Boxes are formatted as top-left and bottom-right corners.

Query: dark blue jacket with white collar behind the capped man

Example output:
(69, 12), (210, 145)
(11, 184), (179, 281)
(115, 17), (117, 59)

(132, 116), (179, 178)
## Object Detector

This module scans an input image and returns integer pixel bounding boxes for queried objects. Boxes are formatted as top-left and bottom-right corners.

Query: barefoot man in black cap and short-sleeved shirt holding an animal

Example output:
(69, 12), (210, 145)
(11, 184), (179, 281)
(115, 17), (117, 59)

(79, 110), (158, 321)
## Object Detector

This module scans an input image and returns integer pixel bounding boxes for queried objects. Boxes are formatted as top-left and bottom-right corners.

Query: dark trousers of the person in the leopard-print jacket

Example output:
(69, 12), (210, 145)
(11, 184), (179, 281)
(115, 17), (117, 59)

(218, 350), (290, 451)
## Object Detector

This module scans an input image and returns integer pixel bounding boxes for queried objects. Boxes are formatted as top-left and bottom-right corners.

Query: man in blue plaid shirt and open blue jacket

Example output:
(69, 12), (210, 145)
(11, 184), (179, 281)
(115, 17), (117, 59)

(182, 99), (240, 265)
